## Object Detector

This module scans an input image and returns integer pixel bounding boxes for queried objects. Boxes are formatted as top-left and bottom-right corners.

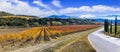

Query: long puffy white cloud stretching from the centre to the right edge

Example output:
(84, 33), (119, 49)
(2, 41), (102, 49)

(59, 5), (120, 14)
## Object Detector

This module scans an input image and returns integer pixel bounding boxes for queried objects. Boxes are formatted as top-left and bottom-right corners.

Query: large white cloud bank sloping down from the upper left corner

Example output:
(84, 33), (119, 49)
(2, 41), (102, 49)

(0, 0), (56, 17)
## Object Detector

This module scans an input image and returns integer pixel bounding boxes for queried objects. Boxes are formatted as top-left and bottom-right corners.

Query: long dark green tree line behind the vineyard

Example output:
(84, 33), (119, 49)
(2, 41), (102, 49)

(0, 17), (95, 27)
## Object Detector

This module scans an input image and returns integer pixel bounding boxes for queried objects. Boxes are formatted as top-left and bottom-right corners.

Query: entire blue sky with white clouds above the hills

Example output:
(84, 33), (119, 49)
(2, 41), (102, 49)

(0, 0), (120, 19)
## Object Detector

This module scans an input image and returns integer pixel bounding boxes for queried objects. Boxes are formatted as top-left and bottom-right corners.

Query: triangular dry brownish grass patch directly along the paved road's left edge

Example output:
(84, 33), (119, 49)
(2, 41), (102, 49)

(56, 31), (96, 52)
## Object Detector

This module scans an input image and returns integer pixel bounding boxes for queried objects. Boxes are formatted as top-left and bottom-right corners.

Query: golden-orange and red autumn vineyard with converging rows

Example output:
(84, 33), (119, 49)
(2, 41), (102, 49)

(0, 25), (97, 46)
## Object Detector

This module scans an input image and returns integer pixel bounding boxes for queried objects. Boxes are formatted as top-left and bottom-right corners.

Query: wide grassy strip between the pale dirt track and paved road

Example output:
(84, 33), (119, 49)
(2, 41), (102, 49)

(43, 28), (99, 52)
